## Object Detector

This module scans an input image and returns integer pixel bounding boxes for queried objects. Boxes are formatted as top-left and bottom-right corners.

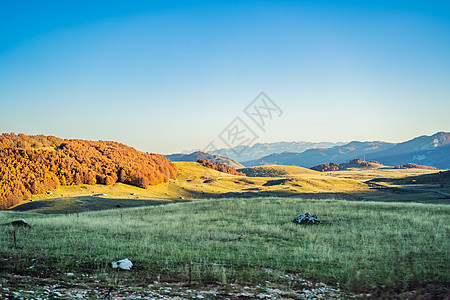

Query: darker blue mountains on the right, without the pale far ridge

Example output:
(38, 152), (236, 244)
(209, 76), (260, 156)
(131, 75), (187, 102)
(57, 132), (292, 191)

(241, 132), (450, 169)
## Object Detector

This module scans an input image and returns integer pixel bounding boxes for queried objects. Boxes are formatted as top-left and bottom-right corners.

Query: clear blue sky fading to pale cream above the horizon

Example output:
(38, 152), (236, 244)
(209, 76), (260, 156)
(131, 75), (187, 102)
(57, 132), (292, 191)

(0, 0), (450, 154)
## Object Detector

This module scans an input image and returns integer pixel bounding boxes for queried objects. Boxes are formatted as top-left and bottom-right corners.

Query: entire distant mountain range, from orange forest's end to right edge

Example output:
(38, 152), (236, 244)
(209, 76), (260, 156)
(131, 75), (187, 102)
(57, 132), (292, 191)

(170, 132), (450, 169)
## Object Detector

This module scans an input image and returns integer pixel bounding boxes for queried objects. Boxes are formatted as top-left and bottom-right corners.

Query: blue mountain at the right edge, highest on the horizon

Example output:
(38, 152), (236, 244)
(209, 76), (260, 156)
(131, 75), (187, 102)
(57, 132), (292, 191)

(366, 132), (450, 169)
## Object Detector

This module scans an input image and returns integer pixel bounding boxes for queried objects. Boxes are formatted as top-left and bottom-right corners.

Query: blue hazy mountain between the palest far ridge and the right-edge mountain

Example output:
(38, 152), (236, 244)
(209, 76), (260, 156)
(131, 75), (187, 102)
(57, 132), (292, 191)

(242, 141), (395, 168)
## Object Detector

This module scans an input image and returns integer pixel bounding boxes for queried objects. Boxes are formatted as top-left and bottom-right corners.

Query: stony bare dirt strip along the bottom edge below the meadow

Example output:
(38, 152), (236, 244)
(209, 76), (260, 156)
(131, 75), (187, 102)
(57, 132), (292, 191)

(0, 269), (348, 299)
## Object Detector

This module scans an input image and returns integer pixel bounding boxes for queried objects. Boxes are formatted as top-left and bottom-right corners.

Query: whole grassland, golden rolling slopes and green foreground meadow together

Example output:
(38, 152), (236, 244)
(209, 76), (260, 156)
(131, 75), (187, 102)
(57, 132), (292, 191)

(0, 162), (450, 299)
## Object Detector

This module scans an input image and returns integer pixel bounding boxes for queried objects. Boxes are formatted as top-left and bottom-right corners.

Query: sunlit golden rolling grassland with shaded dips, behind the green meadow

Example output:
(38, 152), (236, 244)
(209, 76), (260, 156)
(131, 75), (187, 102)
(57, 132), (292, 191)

(13, 162), (450, 213)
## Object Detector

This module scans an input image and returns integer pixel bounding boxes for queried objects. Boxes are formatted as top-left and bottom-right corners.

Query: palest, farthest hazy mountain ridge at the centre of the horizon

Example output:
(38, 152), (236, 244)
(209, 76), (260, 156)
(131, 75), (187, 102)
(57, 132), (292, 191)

(208, 142), (345, 161)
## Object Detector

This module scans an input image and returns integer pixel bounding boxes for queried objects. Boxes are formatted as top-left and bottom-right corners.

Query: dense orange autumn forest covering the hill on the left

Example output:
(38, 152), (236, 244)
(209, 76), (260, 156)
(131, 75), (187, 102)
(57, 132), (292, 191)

(0, 133), (178, 209)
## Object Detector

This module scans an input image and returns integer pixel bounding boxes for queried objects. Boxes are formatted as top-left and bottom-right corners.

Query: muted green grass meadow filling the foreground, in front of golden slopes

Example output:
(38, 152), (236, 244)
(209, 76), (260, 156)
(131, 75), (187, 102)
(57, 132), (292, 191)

(0, 198), (450, 293)
